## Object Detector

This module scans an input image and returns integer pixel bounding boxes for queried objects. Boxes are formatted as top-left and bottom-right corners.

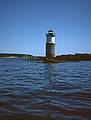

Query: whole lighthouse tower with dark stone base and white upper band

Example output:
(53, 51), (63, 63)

(46, 28), (55, 59)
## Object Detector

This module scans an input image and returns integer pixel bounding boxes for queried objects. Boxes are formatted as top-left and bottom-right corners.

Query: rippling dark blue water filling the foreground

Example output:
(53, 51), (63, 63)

(0, 58), (91, 120)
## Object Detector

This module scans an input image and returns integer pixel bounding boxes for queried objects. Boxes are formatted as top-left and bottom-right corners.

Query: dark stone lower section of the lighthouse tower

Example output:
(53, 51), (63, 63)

(46, 43), (55, 59)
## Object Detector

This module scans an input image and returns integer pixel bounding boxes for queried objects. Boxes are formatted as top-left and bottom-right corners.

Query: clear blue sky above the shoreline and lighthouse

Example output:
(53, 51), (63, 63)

(0, 0), (91, 56)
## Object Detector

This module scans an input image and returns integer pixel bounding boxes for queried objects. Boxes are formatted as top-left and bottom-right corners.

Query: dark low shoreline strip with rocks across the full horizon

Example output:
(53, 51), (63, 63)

(0, 53), (91, 63)
